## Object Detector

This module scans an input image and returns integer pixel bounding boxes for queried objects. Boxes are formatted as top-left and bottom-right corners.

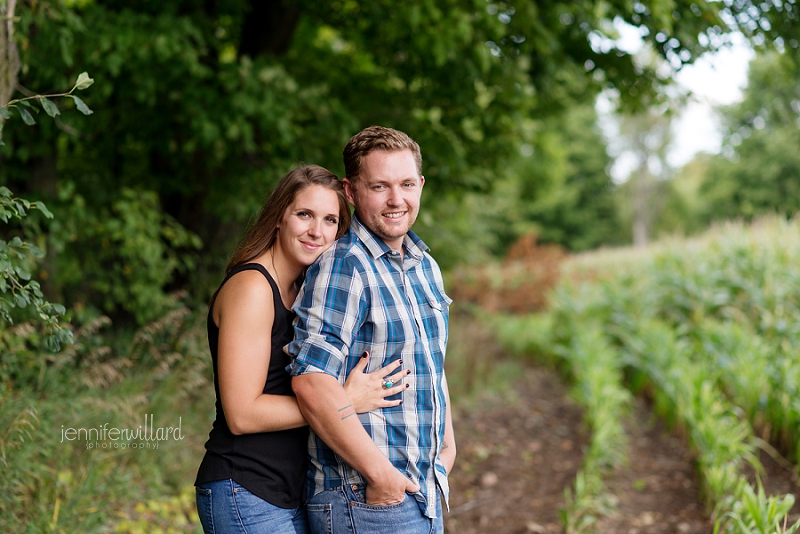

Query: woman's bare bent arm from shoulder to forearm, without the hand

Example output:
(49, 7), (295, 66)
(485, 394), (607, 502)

(214, 271), (307, 435)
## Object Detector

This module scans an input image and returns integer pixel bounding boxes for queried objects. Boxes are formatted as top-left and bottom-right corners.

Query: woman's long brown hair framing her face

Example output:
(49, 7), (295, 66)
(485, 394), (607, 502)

(225, 165), (350, 274)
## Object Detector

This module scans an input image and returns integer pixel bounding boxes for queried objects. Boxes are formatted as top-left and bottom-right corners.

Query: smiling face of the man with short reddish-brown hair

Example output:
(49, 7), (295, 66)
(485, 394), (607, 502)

(344, 150), (425, 251)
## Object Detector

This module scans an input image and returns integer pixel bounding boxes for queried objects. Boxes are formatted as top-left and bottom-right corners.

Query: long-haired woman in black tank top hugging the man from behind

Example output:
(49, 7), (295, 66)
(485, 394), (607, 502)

(195, 165), (408, 534)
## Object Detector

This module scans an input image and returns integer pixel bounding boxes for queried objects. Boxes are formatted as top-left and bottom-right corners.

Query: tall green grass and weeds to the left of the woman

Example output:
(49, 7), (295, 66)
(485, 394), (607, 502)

(0, 300), (209, 533)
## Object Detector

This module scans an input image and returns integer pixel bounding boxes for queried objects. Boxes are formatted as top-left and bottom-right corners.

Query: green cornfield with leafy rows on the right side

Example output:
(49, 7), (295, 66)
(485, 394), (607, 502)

(490, 218), (800, 533)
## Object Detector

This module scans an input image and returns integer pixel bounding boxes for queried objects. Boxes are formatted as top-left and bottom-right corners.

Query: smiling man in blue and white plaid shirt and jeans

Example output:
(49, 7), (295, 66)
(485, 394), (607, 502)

(287, 126), (456, 534)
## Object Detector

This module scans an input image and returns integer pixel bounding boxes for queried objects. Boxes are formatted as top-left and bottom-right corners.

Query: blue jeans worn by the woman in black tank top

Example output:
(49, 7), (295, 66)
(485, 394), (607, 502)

(196, 479), (308, 534)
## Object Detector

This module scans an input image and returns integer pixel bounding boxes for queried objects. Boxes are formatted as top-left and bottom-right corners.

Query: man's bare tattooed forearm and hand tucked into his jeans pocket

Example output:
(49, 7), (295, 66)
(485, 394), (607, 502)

(292, 373), (419, 505)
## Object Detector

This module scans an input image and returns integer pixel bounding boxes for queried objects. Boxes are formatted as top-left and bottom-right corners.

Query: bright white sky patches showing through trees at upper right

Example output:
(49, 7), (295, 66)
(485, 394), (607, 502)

(597, 23), (755, 183)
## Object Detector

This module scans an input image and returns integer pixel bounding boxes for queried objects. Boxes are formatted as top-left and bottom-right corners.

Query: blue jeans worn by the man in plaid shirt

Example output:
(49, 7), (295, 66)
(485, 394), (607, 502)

(306, 486), (444, 534)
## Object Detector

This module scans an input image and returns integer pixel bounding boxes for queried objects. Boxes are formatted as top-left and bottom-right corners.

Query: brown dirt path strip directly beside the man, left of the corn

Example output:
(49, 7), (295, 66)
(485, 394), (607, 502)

(445, 368), (587, 534)
